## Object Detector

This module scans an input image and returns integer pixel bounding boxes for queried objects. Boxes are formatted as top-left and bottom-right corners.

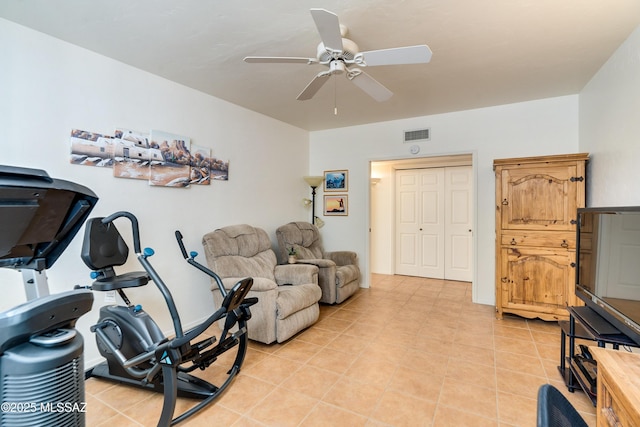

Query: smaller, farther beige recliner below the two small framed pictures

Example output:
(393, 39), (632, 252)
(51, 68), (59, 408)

(276, 222), (360, 304)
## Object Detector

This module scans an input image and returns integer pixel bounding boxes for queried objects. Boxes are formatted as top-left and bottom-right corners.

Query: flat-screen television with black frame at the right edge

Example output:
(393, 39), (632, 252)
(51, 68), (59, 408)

(576, 206), (640, 345)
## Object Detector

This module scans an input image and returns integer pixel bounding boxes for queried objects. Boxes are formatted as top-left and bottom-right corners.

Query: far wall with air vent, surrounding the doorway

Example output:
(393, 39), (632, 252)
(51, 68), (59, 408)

(310, 95), (578, 304)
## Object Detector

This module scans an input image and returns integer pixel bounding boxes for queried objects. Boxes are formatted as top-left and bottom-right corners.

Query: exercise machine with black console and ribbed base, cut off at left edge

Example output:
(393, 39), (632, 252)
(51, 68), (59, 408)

(0, 165), (98, 427)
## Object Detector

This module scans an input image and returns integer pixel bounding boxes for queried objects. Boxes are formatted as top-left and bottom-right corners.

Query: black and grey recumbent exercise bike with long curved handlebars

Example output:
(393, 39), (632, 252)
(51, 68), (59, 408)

(81, 212), (257, 426)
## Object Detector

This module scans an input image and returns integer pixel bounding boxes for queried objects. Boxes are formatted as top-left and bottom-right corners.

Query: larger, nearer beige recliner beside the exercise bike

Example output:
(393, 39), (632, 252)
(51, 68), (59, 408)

(202, 224), (322, 344)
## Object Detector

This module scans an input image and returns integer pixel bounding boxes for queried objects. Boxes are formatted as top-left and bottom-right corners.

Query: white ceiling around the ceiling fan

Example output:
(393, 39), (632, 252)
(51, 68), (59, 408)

(0, 0), (640, 130)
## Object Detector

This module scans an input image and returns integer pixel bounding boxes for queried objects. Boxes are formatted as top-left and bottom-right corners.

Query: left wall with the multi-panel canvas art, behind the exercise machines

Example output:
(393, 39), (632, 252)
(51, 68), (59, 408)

(0, 19), (309, 366)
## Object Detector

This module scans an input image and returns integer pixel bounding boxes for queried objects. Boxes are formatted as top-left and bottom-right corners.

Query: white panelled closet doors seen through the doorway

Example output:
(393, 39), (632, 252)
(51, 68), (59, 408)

(395, 166), (471, 281)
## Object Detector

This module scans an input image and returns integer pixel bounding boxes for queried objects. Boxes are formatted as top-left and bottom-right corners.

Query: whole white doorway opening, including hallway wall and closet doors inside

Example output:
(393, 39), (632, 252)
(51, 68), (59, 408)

(370, 154), (475, 282)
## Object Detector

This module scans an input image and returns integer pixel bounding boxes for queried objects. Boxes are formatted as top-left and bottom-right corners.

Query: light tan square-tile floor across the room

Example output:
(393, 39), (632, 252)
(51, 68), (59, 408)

(86, 275), (595, 427)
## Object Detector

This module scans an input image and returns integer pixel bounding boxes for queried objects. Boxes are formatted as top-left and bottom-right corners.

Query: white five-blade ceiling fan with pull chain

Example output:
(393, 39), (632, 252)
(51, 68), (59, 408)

(244, 9), (431, 102)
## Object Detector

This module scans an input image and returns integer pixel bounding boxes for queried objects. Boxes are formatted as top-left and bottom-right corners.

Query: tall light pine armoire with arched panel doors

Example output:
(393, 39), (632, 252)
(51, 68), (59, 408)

(493, 153), (589, 320)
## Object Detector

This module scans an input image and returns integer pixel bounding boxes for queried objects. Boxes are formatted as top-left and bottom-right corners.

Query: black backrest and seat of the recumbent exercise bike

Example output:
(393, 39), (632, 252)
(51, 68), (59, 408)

(80, 218), (151, 291)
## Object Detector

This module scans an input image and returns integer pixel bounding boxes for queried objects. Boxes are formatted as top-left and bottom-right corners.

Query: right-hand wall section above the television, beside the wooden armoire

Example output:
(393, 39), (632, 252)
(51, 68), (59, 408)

(580, 27), (640, 206)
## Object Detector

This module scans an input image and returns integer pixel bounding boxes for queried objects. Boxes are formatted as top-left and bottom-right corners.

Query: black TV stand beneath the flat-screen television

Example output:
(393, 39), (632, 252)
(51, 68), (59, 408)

(558, 306), (639, 406)
